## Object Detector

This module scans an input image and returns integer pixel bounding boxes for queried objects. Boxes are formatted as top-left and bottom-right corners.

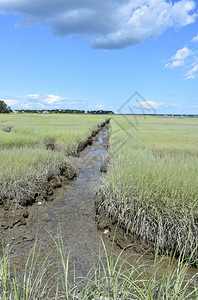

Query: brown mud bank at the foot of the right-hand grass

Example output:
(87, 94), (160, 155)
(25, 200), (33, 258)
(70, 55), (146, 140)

(95, 195), (197, 280)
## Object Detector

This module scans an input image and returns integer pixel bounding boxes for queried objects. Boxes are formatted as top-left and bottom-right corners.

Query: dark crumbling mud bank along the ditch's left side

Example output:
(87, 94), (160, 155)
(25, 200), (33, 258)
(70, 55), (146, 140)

(0, 119), (110, 234)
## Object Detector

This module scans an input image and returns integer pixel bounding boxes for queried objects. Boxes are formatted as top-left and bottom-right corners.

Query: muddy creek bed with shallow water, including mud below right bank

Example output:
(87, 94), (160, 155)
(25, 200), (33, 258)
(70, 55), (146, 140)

(0, 125), (197, 290)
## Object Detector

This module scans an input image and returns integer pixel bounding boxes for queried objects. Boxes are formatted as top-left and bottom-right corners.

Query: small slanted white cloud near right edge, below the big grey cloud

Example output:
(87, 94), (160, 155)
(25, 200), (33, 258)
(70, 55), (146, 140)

(165, 47), (192, 69)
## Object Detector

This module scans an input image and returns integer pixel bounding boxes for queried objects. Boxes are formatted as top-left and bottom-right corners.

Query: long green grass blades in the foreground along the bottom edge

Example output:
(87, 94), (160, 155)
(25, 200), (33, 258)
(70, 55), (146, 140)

(0, 236), (198, 300)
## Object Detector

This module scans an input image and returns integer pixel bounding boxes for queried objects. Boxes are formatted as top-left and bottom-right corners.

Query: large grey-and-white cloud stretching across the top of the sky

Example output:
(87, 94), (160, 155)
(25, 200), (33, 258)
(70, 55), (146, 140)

(0, 0), (197, 49)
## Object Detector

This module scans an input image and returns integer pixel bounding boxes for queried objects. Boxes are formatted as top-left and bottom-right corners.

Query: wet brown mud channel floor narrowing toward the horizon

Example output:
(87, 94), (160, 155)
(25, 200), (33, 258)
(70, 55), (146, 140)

(1, 120), (111, 277)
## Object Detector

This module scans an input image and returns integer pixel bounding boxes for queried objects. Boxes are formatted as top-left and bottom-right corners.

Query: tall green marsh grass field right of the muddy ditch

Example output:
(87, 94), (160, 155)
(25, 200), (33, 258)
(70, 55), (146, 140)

(99, 117), (198, 264)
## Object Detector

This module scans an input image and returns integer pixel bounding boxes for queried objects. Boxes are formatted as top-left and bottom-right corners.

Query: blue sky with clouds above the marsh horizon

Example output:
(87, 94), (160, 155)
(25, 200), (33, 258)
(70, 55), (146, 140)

(0, 0), (198, 114)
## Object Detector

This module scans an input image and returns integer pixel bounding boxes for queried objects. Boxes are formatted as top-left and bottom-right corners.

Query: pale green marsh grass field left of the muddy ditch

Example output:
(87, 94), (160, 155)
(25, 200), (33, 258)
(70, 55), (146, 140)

(0, 114), (106, 205)
